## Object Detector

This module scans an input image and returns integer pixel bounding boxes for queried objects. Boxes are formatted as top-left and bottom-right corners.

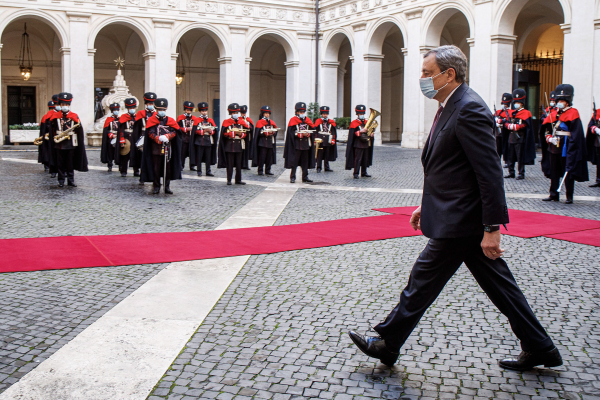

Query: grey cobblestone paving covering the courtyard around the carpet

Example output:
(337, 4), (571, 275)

(0, 146), (600, 400)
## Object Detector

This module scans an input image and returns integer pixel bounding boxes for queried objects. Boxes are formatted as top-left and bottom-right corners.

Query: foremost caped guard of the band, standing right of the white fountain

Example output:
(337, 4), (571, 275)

(141, 98), (181, 194)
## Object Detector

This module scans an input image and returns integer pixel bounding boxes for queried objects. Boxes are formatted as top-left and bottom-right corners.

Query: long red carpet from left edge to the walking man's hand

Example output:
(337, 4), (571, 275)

(0, 215), (420, 272)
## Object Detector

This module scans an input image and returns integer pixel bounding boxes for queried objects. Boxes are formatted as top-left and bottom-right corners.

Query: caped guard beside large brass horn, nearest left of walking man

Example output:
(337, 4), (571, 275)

(346, 104), (374, 179)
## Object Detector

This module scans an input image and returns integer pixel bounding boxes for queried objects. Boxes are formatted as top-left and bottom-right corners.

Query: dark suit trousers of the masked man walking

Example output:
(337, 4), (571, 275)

(374, 235), (554, 351)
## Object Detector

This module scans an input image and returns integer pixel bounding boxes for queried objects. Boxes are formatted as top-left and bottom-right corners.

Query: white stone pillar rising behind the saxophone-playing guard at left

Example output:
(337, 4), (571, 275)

(61, 12), (95, 130)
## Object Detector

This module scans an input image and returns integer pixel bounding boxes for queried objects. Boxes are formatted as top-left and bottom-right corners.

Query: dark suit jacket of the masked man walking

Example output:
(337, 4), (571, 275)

(421, 83), (508, 238)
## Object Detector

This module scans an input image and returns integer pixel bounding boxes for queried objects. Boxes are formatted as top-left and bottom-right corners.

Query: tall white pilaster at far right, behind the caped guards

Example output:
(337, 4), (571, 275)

(561, 0), (598, 125)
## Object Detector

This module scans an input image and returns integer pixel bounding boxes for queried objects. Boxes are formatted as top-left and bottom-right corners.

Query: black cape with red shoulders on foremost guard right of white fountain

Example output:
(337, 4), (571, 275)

(141, 116), (182, 182)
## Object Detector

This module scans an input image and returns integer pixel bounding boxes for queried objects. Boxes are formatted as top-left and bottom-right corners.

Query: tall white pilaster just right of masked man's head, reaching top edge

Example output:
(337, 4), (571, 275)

(467, 0), (495, 107)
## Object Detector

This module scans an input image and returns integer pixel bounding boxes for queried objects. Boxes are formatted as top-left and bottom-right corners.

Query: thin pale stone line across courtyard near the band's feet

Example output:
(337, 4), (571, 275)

(1, 157), (600, 201)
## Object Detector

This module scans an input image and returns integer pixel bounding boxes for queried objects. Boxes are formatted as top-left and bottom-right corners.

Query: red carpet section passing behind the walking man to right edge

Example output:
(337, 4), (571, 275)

(375, 206), (600, 238)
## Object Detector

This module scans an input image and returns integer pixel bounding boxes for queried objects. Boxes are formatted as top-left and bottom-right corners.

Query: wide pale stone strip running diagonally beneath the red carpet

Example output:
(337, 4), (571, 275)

(0, 173), (297, 400)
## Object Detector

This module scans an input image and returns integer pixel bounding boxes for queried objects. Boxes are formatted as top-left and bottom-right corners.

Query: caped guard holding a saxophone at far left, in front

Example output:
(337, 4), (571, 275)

(49, 93), (88, 187)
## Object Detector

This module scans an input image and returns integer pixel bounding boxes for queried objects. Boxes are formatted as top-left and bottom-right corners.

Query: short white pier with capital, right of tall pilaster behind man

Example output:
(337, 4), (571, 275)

(490, 35), (517, 105)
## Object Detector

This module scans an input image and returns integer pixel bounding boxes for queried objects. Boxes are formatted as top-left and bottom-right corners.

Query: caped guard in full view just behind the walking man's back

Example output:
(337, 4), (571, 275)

(504, 89), (535, 180)
